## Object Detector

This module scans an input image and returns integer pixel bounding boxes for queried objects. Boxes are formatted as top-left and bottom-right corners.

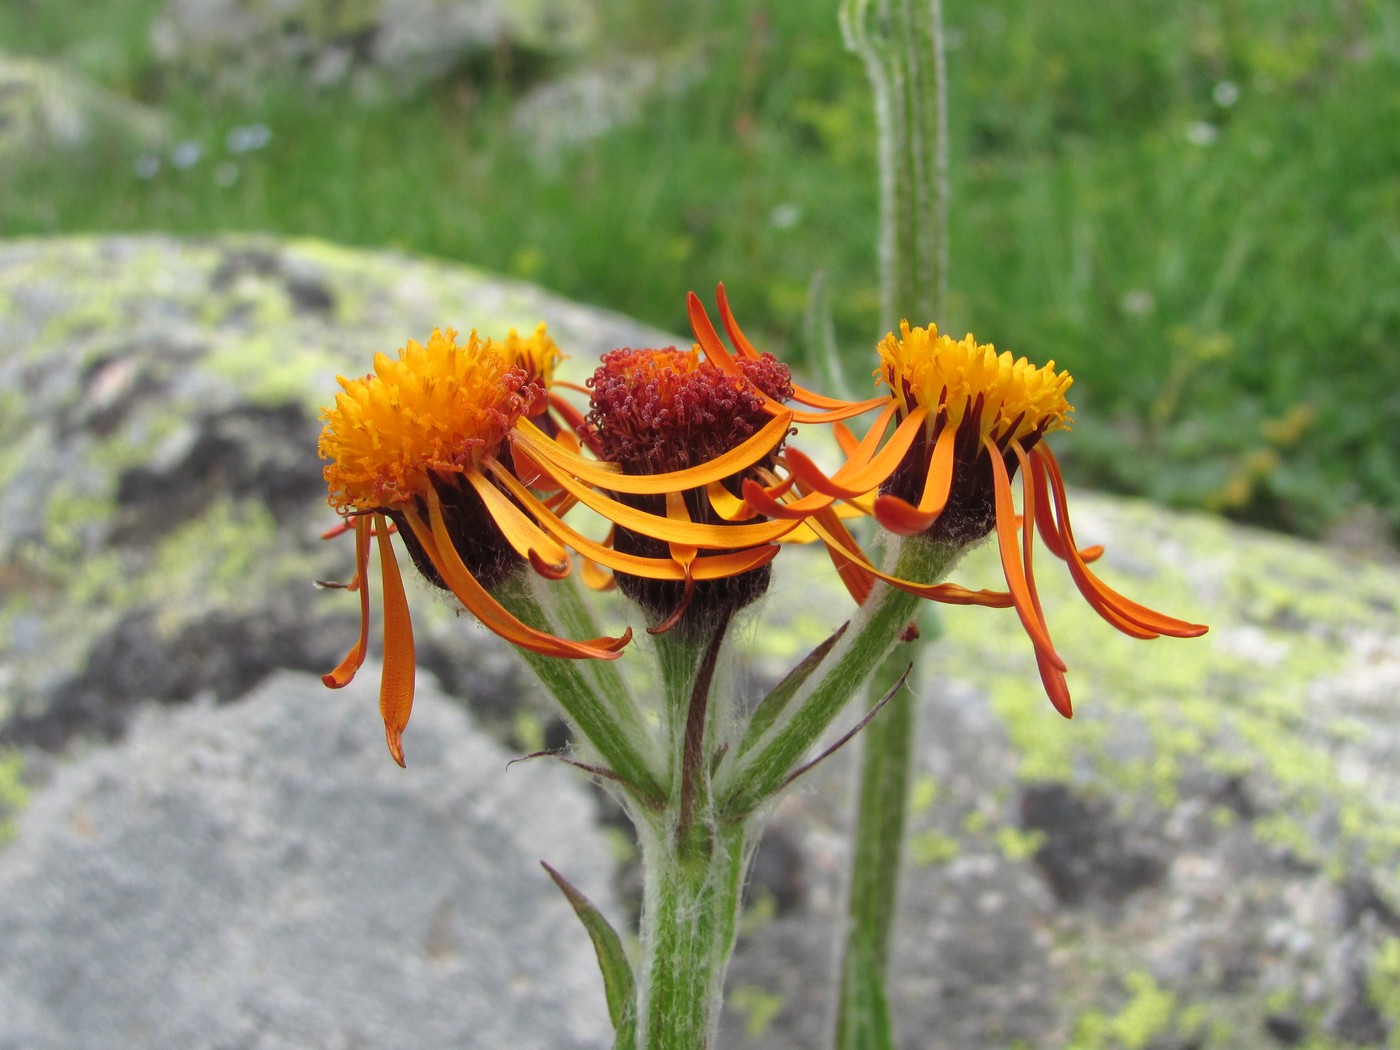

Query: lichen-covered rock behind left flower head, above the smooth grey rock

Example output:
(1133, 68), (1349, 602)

(0, 237), (672, 748)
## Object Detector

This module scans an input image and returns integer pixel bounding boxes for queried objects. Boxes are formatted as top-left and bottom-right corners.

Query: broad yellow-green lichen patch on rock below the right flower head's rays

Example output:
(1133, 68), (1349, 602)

(938, 494), (1400, 896)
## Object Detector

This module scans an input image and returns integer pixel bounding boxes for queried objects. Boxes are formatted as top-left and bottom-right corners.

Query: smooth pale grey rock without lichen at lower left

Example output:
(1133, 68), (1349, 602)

(0, 673), (612, 1050)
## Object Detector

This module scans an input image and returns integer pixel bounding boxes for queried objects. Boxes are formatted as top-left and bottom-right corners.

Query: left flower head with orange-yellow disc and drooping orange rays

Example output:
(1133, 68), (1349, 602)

(319, 329), (627, 764)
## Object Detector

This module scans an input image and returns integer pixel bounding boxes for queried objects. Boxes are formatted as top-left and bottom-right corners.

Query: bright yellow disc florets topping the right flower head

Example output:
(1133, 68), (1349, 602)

(875, 321), (1074, 442)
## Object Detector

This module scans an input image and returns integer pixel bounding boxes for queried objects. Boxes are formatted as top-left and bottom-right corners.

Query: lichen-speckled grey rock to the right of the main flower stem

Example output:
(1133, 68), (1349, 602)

(722, 506), (1400, 1050)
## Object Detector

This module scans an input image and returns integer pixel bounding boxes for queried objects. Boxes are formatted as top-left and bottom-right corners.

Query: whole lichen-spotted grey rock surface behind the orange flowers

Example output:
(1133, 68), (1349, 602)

(0, 237), (1400, 1050)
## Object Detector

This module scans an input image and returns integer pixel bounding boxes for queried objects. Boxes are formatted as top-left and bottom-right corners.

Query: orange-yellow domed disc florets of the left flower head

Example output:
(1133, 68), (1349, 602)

(318, 329), (532, 512)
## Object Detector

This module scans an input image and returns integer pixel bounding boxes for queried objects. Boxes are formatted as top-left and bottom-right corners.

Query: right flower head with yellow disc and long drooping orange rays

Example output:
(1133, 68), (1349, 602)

(692, 288), (1207, 717)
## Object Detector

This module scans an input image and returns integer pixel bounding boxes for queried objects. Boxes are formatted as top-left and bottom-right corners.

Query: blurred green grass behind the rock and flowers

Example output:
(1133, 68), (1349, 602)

(0, 0), (1400, 545)
